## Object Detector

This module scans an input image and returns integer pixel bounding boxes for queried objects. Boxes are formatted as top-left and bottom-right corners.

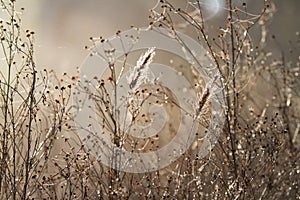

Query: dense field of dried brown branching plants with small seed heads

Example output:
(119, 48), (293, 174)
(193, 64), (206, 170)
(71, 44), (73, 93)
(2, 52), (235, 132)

(0, 0), (300, 200)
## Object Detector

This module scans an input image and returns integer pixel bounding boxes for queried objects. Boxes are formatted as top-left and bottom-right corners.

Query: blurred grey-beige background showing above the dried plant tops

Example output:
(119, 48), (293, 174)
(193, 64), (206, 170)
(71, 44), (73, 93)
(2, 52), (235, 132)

(14, 0), (300, 74)
